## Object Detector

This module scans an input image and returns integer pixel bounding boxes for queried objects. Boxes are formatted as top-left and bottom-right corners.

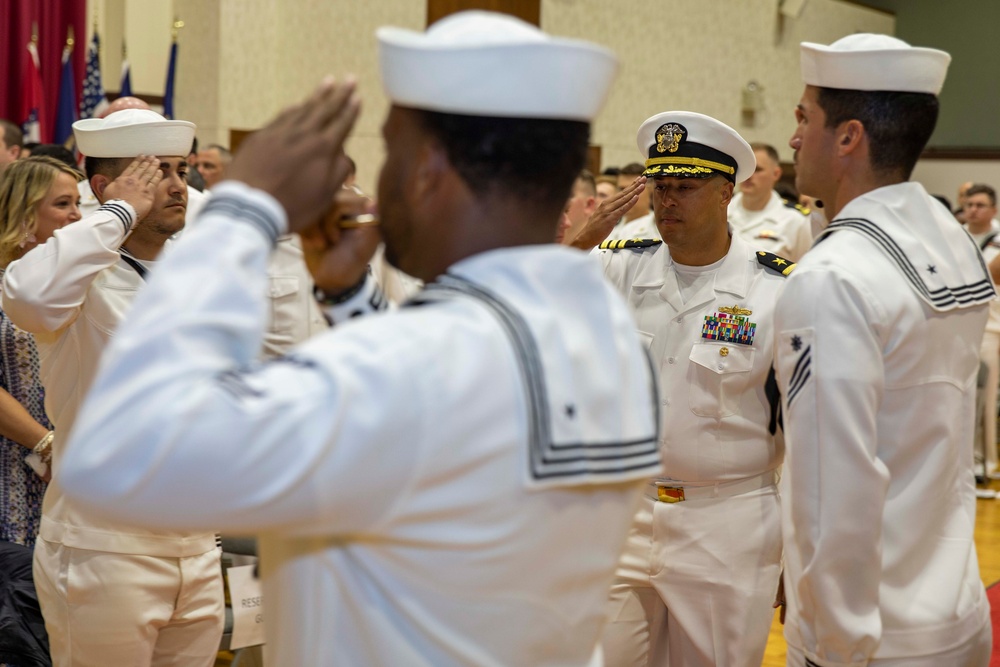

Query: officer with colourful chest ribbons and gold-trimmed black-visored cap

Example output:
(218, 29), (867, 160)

(599, 111), (793, 667)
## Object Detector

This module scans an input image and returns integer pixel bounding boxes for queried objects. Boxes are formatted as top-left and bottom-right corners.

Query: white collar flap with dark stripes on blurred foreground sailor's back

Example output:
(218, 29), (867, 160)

(410, 246), (661, 490)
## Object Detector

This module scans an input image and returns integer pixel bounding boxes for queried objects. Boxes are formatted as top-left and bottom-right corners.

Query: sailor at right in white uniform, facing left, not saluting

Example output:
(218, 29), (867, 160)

(775, 34), (994, 667)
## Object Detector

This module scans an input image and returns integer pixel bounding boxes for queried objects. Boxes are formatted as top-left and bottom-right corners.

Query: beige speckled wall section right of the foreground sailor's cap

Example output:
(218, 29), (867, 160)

(541, 0), (895, 166)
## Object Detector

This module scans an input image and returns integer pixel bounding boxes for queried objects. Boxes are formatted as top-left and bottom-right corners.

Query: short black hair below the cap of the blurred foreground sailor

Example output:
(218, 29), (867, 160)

(412, 109), (590, 211)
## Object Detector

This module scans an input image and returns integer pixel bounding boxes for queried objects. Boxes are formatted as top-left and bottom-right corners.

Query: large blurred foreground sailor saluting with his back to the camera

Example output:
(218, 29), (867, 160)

(56, 12), (661, 667)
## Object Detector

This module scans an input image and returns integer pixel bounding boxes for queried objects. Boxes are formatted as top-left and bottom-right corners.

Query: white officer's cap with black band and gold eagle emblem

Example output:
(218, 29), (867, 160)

(636, 111), (757, 183)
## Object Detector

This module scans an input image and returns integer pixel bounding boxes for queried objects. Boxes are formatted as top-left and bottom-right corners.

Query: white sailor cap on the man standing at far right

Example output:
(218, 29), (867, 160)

(801, 33), (951, 95)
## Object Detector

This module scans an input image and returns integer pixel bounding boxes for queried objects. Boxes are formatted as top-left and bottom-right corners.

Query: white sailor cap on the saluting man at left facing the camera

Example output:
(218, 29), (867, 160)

(73, 109), (195, 157)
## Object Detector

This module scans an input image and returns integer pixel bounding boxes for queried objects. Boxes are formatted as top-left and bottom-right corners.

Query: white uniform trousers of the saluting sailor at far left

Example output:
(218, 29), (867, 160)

(34, 538), (225, 667)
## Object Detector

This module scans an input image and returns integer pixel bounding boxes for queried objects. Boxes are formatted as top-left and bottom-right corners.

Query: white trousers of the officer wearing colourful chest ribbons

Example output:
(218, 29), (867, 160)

(602, 485), (781, 667)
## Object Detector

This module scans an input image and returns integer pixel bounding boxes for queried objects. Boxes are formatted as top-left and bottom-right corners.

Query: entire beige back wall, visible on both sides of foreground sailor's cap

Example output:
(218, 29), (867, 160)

(91, 0), (895, 190)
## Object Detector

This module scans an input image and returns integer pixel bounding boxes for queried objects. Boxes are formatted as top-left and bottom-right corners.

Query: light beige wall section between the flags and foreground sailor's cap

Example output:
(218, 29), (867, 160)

(196, 0), (426, 190)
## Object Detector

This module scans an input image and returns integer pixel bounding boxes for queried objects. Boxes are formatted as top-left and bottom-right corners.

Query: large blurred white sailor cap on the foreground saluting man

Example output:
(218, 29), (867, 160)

(375, 11), (618, 122)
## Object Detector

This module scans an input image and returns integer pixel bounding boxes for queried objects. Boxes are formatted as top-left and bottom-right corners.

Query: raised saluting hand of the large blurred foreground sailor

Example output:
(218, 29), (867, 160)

(226, 78), (361, 232)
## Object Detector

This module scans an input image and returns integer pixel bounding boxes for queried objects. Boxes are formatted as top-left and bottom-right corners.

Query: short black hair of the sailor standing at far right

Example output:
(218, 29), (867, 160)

(817, 88), (940, 179)
